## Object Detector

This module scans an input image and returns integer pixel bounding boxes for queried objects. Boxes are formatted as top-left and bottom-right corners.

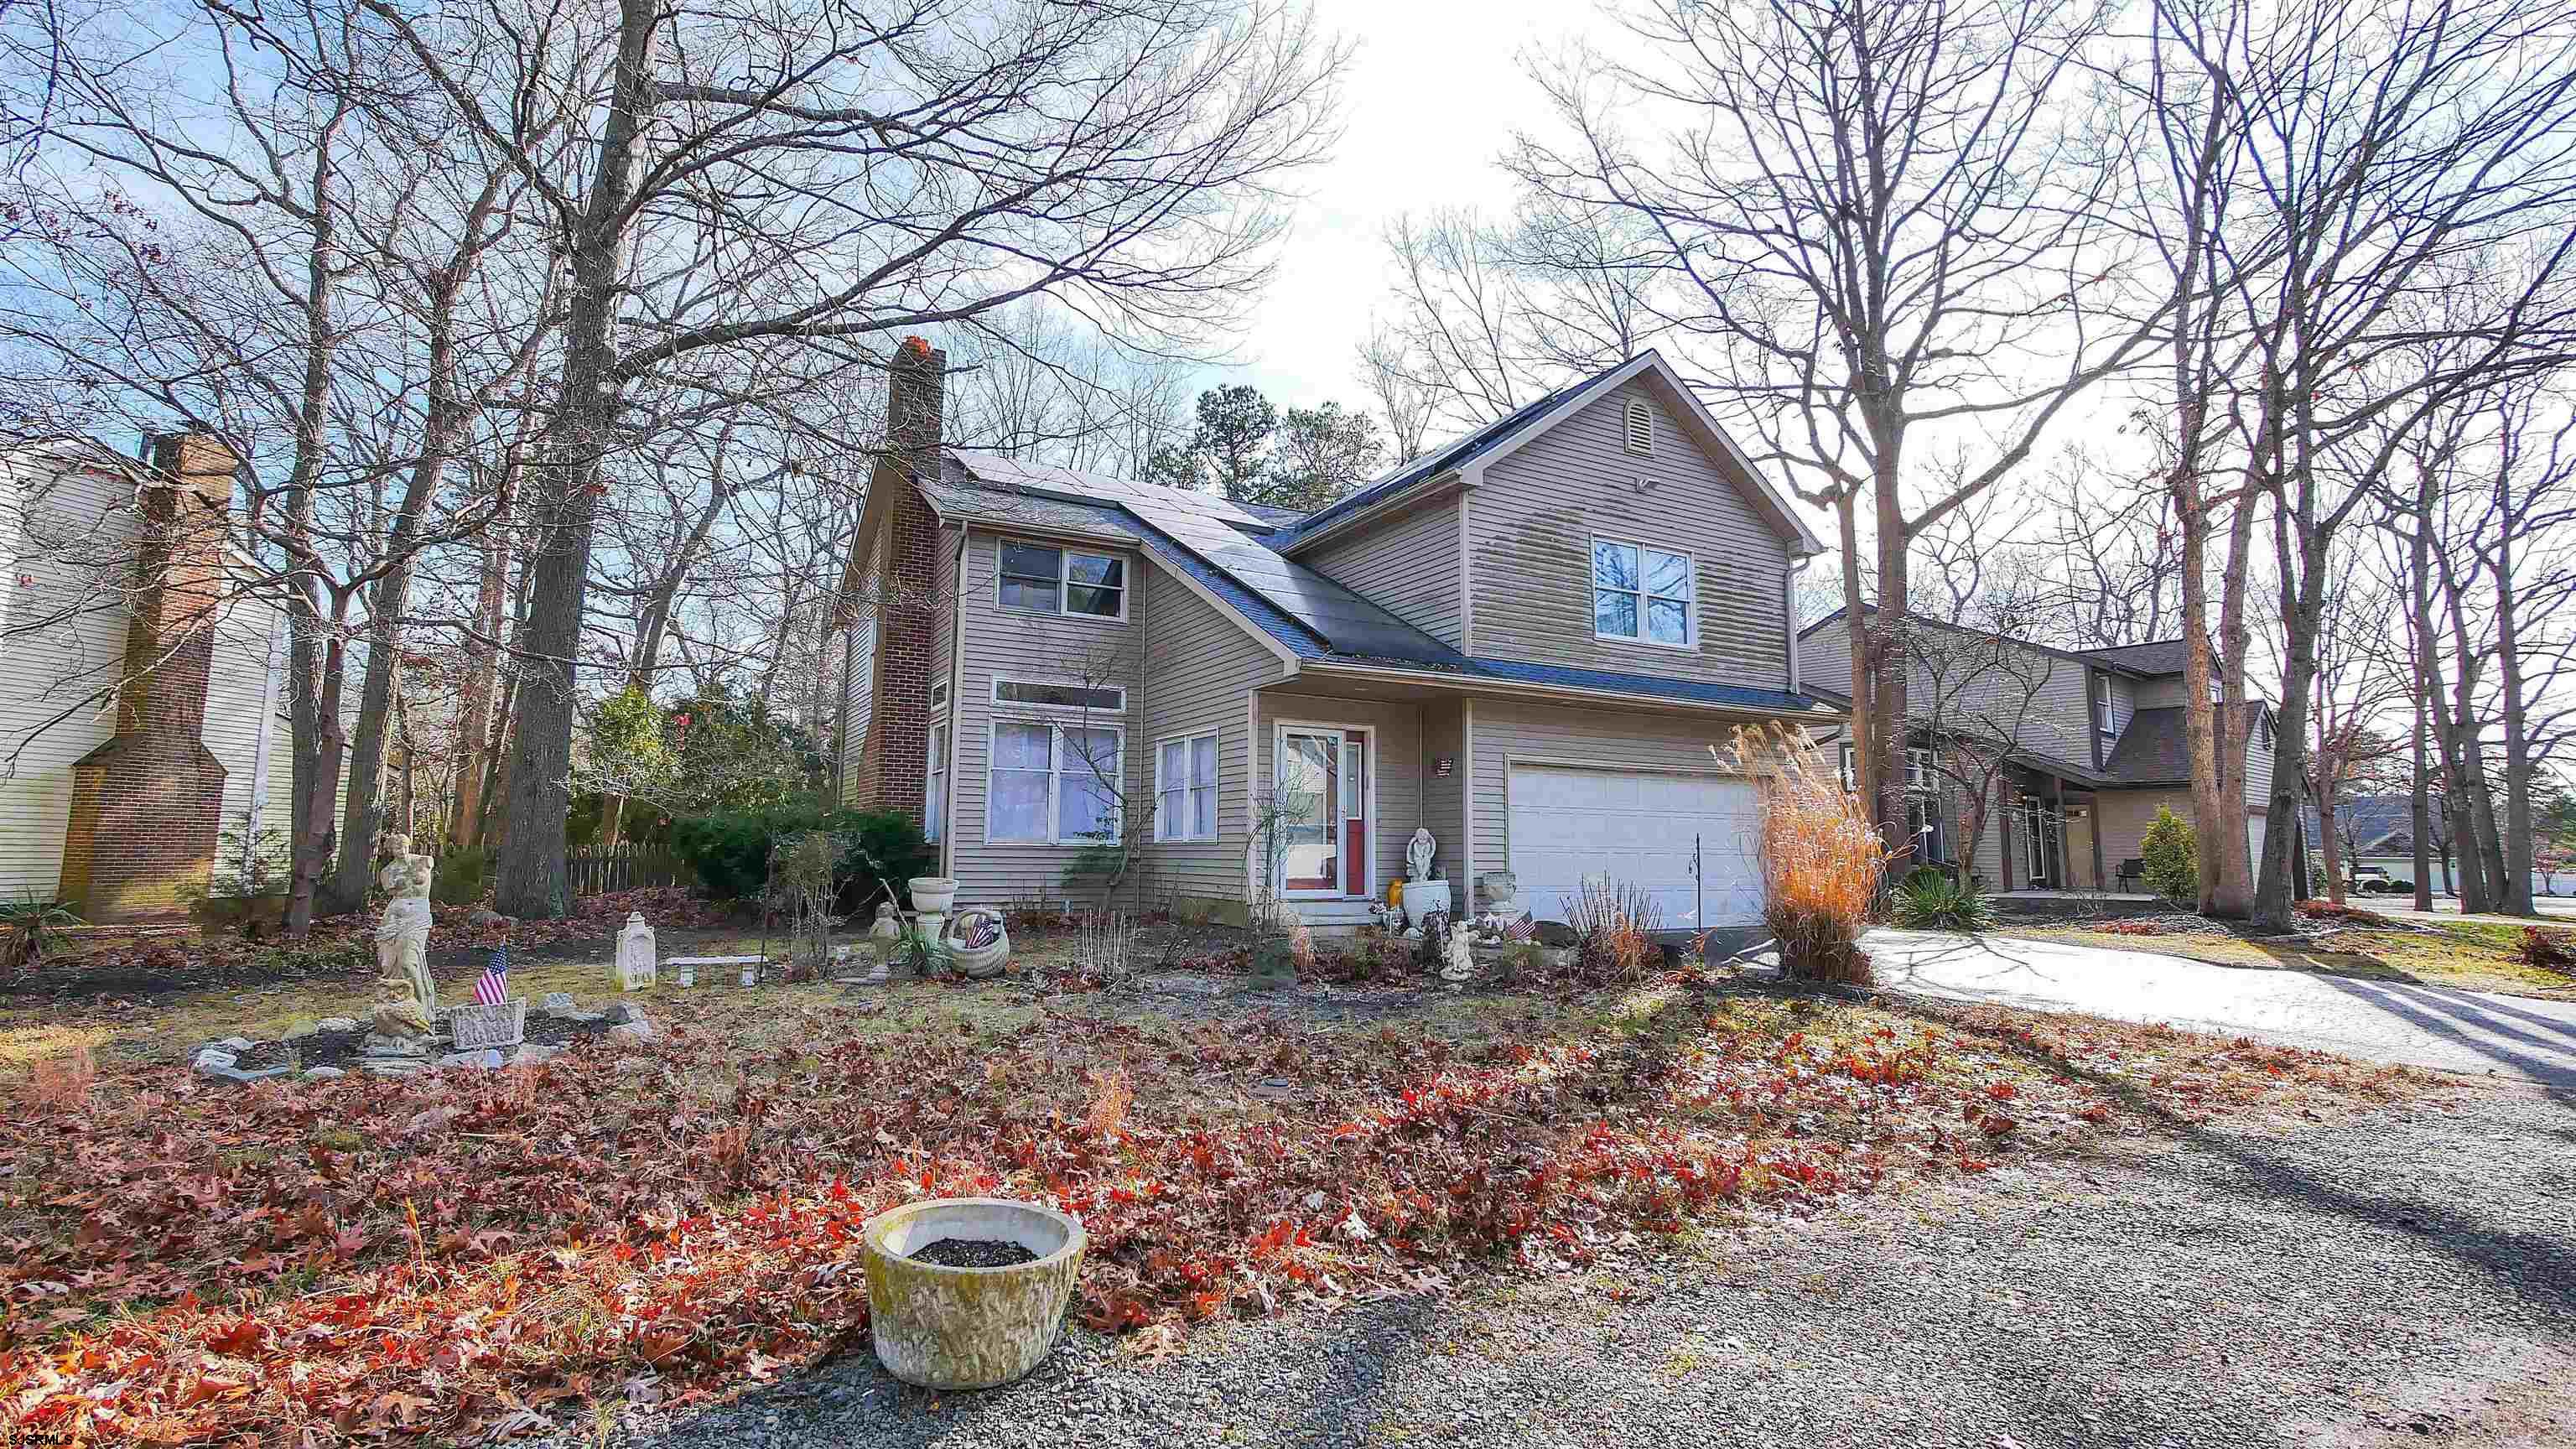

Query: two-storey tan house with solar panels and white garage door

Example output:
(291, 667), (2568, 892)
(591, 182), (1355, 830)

(843, 343), (1839, 928)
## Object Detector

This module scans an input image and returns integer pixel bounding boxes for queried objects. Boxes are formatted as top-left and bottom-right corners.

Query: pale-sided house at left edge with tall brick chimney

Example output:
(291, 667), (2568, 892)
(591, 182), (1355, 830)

(0, 436), (288, 921)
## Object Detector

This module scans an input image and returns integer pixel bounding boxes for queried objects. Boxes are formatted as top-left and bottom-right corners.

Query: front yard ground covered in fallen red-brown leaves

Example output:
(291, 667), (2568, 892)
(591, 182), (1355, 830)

(0, 982), (2403, 1444)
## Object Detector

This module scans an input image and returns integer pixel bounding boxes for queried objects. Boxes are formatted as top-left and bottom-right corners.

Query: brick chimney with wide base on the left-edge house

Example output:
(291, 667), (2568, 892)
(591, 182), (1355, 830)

(62, 434), (240, 921)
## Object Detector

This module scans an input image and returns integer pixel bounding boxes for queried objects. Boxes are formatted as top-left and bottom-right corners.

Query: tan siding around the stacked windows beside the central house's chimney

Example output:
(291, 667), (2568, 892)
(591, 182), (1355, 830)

(932, 518), (1154, 905)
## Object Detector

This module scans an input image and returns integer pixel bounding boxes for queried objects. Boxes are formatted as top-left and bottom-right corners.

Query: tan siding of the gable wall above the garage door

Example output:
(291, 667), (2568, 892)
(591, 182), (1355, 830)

(1468, 379), (1788, 685)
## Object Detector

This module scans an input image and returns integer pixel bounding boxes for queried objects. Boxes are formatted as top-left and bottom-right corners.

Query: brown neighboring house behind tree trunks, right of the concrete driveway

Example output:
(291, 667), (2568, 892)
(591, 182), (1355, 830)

(1800, 609), (2305, 890)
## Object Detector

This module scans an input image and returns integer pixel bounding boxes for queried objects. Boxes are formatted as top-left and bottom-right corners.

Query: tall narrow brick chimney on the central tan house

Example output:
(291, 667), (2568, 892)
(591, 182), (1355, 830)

(850, 338), (948, 820)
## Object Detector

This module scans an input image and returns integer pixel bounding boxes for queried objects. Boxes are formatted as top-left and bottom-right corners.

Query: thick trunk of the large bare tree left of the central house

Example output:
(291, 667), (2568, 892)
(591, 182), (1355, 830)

(495, 0), (659, 921)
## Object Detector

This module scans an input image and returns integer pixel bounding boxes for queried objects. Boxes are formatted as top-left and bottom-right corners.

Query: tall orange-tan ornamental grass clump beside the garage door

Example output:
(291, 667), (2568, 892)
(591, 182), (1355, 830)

(1731, 724), (1888, 985)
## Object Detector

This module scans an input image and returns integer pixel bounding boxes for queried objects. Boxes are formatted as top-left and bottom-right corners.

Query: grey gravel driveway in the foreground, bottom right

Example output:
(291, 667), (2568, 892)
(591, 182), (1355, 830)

(584, 1083), (2576, 1449)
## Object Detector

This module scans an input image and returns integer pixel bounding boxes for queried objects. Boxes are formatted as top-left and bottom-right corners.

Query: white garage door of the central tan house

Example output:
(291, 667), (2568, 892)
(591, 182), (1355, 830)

(1512, 766), (1762, 931)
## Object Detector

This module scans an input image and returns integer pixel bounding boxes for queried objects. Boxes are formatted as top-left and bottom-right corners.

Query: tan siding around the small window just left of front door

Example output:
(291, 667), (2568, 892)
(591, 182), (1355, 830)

(1134, 567), (1280, 900)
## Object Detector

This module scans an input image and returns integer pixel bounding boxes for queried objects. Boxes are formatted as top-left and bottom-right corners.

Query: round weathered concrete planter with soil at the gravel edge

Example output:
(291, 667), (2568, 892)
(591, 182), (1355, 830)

(865, 1197), (1084, 1389)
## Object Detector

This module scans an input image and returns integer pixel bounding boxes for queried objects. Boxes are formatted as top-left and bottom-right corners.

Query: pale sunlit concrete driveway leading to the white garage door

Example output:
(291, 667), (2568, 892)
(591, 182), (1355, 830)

(1862, 931), (2576, 1091)
